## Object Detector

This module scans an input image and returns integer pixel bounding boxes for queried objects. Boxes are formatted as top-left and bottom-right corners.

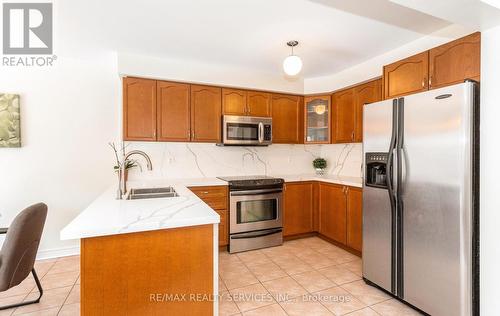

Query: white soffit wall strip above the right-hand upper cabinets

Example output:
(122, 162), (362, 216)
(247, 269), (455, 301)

(304, 25), (474, 94)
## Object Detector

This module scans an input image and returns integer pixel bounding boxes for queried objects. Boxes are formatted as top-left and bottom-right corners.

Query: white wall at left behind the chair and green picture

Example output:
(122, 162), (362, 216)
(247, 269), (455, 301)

(0, 53), (119, 257)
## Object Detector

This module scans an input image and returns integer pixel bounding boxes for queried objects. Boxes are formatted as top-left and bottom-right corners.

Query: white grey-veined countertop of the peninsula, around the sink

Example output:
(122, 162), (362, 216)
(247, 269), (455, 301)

(60, 178), (222, 240)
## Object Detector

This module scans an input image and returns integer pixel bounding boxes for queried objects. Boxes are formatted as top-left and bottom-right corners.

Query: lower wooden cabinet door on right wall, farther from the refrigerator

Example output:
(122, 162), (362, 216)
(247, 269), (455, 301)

(319, 183), (347, 245)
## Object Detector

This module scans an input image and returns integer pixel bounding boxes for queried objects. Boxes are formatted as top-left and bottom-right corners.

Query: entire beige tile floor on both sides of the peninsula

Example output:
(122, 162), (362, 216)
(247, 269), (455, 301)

(0, 237), (419, 316)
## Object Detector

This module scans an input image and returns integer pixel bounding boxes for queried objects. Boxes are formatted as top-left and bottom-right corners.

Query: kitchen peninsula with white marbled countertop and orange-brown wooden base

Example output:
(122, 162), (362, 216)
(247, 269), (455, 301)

(61, 179), (226, 315)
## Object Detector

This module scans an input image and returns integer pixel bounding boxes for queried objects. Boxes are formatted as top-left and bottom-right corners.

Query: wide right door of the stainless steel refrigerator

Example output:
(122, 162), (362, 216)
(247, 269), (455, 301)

(399, 83), (473, 316)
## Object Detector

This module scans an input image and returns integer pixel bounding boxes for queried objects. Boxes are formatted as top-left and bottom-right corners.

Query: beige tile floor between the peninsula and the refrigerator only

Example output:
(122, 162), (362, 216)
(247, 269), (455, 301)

(219, 237), (420, 316)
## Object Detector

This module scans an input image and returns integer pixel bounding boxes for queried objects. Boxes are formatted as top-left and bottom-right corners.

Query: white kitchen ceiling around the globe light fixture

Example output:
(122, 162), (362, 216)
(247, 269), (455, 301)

(59, 0), (449, 77)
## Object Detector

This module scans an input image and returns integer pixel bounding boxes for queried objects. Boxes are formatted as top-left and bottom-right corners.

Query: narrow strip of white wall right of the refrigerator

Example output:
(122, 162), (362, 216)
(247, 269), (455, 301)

(480, 27), (500, 316)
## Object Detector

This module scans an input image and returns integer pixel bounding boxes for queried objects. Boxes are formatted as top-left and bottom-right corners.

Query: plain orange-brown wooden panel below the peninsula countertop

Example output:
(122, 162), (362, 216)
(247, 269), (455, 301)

(80, 225), (214, 316)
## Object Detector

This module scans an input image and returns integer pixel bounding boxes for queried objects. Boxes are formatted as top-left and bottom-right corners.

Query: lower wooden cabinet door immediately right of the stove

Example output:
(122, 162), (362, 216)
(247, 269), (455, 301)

(283, 182), (314, 236)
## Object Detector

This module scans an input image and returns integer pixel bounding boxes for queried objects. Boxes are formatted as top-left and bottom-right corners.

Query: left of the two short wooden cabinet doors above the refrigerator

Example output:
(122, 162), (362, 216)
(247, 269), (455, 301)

(384, 51), (429, 99)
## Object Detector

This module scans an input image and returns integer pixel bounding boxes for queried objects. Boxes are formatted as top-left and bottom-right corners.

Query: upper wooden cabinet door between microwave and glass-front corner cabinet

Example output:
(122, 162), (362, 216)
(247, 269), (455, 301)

(271, 94), (304, 144)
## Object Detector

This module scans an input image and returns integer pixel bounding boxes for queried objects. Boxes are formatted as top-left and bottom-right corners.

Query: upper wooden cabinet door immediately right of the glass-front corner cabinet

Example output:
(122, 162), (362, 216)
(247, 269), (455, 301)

(332, 88), (356, 143)
